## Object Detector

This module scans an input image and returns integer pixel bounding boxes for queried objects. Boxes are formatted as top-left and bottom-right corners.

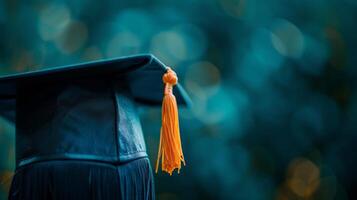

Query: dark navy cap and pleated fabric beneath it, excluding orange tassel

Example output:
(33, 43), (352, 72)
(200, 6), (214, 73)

(0, 55), (190, 200)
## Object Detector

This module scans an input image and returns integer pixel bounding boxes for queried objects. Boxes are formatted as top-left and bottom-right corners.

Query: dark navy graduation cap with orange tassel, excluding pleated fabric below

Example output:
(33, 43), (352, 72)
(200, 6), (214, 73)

(0, 55), (190, 174)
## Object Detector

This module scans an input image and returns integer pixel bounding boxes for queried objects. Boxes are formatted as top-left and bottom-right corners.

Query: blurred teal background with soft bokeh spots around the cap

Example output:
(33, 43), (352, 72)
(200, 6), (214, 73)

(0, 0), (357, 200)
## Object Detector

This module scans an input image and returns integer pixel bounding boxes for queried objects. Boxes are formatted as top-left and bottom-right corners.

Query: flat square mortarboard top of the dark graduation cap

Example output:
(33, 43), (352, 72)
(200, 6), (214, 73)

(0, 54), (190, 121)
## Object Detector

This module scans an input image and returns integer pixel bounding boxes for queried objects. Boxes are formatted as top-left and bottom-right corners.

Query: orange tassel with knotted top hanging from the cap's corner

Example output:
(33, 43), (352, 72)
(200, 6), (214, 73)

(155, 67), (185, 175)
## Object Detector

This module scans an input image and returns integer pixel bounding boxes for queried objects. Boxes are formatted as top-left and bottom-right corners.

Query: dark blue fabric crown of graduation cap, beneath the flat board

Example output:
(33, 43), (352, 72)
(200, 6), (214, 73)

(16, 77), (147, 166)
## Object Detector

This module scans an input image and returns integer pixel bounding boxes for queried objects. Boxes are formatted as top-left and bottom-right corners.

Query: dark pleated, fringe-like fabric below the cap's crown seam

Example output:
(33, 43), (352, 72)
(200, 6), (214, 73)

(9, 158), (155, 200)
